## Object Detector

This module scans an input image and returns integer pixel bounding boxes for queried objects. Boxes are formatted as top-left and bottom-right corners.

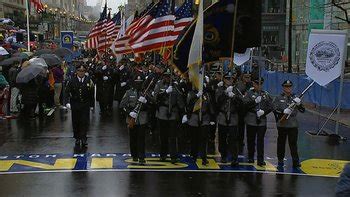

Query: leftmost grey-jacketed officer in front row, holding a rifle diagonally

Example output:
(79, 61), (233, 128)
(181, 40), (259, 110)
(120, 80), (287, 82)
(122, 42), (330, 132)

(119, 76), (150, 164)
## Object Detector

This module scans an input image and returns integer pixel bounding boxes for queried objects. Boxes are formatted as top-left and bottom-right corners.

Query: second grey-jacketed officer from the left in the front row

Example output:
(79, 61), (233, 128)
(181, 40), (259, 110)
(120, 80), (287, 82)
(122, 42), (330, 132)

(154, 69), (185, 163)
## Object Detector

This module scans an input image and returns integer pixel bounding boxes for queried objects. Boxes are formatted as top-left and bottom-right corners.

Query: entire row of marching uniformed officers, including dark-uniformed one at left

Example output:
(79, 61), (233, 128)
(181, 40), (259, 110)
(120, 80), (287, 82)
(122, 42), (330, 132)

(67, 60), (305, 167)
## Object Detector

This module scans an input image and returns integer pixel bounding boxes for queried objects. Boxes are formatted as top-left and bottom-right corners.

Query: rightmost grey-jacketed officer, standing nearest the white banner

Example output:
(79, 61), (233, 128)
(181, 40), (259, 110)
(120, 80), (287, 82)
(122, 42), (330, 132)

(274, 80), (305, 168)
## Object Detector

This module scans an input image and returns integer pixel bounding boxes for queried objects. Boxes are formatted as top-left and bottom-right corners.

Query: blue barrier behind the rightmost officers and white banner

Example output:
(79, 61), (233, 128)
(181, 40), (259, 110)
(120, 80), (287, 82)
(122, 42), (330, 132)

(262, 71), (350, 109)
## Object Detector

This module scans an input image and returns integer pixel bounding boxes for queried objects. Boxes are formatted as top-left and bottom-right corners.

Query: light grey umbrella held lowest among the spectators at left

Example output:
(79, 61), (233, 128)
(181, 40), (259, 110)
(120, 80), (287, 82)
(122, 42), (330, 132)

(16, 65), (46, 83)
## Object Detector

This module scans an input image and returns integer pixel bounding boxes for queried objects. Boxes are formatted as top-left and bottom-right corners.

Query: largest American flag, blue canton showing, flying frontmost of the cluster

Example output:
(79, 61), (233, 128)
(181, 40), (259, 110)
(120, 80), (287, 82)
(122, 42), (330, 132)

(129, 0), (175, 53)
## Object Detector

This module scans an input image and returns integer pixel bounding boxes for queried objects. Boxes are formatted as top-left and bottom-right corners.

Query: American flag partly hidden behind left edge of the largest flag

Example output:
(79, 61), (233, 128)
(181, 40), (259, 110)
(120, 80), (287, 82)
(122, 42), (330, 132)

(112, 2), (156, 54)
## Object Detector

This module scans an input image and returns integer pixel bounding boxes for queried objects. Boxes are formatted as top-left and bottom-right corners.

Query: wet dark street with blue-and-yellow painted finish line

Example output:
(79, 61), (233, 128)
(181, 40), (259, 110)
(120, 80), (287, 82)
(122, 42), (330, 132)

(0, 104), (350, 196)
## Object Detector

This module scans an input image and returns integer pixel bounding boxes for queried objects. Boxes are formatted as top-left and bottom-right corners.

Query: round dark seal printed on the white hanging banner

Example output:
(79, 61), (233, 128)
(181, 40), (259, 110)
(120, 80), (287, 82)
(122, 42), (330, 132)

(310, 41), (340, 72)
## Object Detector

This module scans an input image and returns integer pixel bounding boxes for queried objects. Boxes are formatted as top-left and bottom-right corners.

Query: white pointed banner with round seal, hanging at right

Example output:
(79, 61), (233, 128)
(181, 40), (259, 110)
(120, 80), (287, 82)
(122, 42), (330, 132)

(306, 30), (347, 86)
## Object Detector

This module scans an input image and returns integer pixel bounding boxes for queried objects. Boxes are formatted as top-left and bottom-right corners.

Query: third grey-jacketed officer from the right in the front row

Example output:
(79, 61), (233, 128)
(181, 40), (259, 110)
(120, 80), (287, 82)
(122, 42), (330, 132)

(216, 72), (242, 167)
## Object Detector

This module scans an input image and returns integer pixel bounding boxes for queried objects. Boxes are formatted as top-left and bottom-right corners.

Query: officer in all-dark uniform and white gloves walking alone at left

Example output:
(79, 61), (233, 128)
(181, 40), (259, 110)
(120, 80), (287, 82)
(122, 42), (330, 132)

(66, 66), (95, 147)
